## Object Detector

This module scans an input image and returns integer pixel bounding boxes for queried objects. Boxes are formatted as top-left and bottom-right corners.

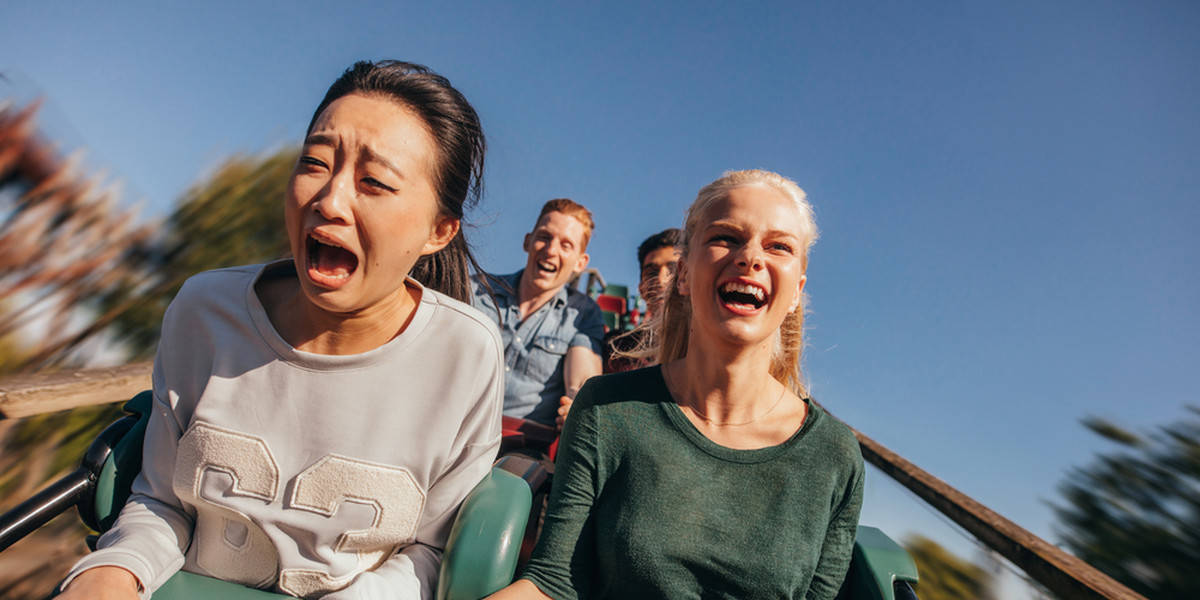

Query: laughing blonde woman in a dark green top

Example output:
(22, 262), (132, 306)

(494, 170), (863, 599)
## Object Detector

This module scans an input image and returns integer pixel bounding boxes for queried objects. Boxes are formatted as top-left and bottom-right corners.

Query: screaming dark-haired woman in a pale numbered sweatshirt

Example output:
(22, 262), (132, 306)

(60, 61), (503, 599)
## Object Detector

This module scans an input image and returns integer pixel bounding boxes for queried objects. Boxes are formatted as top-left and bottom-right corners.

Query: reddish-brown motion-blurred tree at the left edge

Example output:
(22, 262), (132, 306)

(0, 100), (151, 370)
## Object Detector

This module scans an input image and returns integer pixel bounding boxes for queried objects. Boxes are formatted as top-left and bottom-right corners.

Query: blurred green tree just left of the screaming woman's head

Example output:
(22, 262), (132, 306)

(100, 149), (296, 358)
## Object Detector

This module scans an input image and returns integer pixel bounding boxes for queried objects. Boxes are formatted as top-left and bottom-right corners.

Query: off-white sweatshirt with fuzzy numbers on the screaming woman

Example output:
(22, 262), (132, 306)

(65, 262), (504, 600)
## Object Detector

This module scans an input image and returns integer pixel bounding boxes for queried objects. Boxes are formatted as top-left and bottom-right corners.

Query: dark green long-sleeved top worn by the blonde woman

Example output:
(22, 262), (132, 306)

(522, 367), (863, 599)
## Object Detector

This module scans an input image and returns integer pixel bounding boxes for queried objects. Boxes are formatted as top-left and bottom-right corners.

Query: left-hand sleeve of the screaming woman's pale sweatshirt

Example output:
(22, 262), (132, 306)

(61, 350), (196, 599)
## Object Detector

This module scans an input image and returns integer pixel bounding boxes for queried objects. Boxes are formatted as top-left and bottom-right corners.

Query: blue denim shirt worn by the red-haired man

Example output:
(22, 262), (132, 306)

(470, 269), (604, 425)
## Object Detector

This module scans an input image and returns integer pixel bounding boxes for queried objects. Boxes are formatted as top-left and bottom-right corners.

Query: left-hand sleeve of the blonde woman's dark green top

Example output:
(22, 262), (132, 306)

(522, 380), (600, 600)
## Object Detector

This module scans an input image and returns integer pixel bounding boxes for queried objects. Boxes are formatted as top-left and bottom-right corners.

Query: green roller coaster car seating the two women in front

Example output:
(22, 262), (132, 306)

(0, 391), (917, 600)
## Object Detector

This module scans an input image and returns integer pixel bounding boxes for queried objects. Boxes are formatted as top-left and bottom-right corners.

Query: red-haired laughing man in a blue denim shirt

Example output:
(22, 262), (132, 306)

(472, 198), (604, 427)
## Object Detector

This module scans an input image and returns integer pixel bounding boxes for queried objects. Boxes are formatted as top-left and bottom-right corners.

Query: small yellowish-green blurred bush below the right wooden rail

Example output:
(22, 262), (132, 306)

(904, 535), (991, 600)
